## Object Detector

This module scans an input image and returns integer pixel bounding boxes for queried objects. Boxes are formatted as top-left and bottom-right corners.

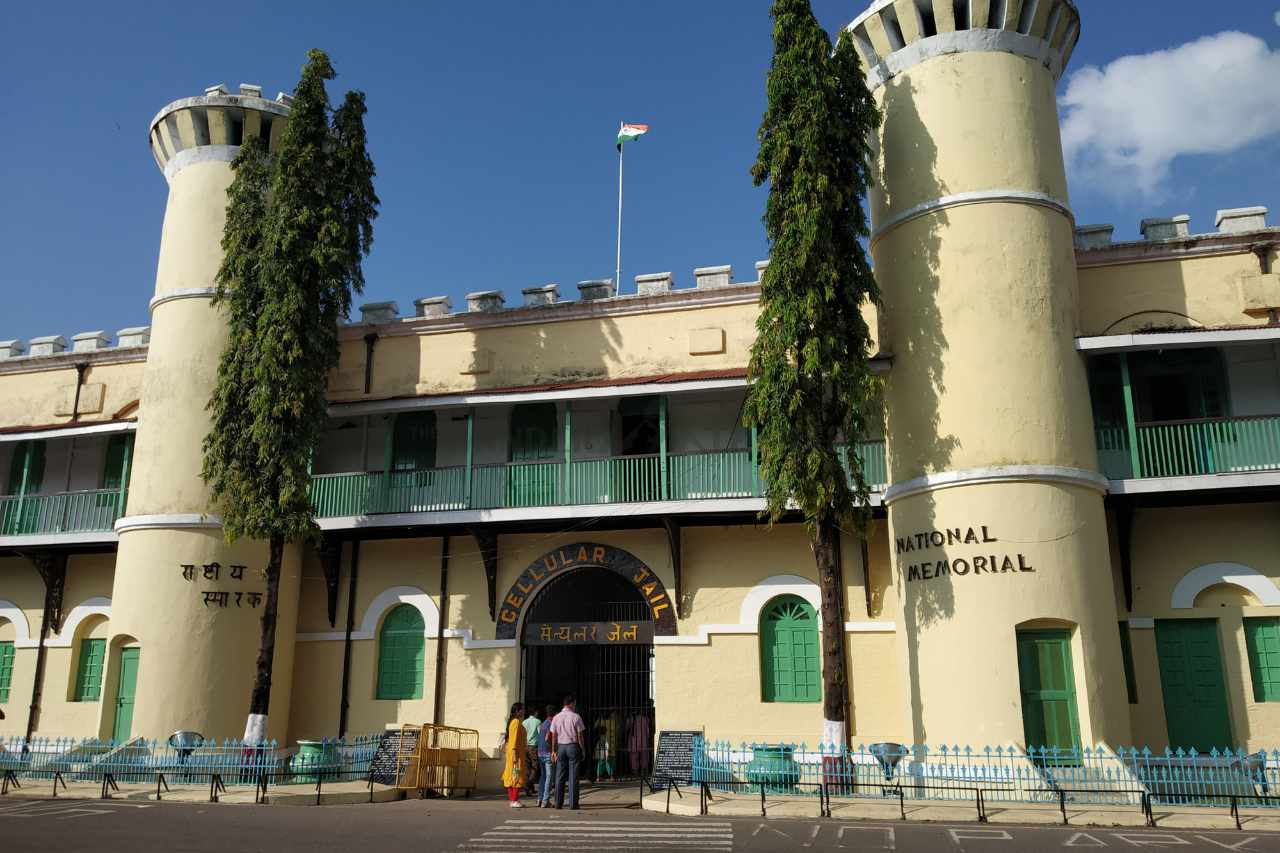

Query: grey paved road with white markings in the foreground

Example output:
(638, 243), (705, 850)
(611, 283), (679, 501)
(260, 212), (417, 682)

(0, 798), (1280, 853)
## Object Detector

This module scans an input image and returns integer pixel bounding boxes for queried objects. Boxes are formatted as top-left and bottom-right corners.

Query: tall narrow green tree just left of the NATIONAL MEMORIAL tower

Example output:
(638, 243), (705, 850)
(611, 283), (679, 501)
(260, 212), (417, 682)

(744, 0), (879, 745)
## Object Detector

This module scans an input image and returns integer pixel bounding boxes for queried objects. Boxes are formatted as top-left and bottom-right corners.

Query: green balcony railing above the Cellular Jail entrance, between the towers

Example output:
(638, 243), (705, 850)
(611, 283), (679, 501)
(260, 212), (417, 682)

(311, 442), (886, 519)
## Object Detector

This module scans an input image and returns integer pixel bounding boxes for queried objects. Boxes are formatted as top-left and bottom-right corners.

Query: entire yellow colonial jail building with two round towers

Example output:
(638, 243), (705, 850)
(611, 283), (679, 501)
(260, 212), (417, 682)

(0, 0), (1280, 770)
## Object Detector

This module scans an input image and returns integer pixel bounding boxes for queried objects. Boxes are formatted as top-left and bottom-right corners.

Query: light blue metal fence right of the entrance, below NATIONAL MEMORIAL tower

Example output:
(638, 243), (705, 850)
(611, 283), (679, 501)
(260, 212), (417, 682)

(692, 740), (1280, 808)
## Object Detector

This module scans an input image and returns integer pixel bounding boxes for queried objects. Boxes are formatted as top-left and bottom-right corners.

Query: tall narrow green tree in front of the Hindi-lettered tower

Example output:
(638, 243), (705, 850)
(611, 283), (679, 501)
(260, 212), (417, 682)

(202, 50), (378, 743)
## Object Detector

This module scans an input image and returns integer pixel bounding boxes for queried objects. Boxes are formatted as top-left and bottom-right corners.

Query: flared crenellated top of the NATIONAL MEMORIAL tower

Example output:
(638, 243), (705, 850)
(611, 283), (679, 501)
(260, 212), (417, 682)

(847, 0), (1080, 91)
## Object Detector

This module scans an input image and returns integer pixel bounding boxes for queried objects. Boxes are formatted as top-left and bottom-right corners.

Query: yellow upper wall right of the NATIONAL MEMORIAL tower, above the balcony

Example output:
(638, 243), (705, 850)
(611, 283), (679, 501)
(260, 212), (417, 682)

(1079, 251), (1267, 334)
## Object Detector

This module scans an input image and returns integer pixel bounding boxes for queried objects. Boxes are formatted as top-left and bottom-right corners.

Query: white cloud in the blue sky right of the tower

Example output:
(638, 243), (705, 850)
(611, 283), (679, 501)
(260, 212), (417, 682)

(1059, 31), (1280, 196)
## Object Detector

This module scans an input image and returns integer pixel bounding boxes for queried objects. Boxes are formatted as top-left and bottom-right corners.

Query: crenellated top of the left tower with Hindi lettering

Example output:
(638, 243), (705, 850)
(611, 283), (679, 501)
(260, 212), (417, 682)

(150, 83), (293, 181)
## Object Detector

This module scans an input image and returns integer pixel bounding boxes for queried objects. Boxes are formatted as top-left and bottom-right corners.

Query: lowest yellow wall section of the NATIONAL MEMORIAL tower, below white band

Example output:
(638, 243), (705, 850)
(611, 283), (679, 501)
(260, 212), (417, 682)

(890, 483), (1130, 745)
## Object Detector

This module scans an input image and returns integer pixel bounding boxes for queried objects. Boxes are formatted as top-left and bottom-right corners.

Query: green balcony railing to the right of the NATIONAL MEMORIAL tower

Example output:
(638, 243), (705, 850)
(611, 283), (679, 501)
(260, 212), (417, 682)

(1097, 415), (1280, 479)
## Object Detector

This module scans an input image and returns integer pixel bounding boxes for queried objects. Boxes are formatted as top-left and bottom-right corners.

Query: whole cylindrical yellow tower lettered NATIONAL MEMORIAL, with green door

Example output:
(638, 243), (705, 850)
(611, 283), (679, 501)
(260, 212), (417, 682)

(850, 0), (1129, 745)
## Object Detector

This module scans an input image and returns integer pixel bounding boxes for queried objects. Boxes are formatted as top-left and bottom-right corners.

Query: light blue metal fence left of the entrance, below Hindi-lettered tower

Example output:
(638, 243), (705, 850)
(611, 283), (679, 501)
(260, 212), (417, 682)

(0, 735), (379, 785)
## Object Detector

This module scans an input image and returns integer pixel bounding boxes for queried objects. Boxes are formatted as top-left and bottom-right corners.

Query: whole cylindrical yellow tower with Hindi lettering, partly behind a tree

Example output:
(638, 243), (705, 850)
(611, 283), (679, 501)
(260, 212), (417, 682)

(102, 86), (298, 739)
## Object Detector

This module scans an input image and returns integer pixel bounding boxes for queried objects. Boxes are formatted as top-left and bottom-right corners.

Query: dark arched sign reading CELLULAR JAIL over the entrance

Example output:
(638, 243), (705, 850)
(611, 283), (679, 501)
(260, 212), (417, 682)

(497, 542), (676, 642)
